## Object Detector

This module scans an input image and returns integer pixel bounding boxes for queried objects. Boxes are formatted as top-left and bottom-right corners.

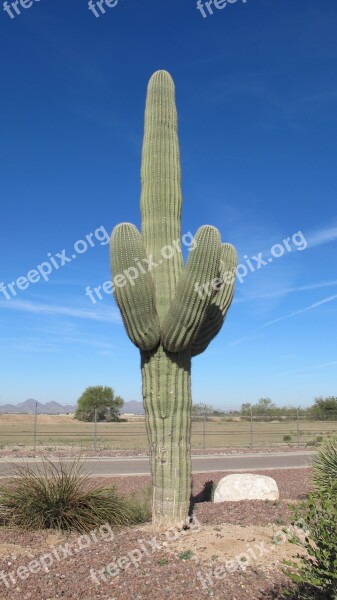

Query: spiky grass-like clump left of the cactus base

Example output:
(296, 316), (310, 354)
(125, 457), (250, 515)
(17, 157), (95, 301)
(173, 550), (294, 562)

(0, 459), (148, 533)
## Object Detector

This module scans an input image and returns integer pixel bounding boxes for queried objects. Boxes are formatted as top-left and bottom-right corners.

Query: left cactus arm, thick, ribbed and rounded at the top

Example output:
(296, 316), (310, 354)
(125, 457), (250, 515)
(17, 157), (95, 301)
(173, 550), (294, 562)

(110, 223), (160, 350)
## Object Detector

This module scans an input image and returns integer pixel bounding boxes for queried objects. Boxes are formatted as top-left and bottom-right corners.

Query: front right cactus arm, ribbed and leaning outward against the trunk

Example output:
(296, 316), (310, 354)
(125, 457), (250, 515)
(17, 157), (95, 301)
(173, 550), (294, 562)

(162, 225), (221, 352)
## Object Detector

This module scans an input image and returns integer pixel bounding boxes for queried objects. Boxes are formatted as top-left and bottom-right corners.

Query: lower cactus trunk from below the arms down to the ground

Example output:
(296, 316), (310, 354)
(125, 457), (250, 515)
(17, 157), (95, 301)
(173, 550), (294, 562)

(141, 346), (191, 528)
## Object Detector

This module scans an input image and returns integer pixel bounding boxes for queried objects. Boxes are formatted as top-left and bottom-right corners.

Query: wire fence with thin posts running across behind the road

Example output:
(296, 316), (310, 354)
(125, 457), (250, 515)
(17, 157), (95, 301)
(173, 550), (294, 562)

(0, 410), (337, 452)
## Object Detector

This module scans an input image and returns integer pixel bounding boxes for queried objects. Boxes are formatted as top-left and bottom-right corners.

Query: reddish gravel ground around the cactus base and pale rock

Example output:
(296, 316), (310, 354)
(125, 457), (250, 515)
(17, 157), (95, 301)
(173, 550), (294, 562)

(0, 469), (310, 600)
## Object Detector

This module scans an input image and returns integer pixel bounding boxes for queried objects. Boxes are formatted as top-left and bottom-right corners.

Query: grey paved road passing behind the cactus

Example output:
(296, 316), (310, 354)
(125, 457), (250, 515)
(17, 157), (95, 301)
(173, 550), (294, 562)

(0, 452), (315, 476)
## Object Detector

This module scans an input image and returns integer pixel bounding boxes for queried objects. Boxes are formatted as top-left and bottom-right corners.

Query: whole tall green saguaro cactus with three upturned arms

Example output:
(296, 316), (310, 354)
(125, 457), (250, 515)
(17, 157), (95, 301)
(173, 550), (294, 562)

(111, 71), (236, 527)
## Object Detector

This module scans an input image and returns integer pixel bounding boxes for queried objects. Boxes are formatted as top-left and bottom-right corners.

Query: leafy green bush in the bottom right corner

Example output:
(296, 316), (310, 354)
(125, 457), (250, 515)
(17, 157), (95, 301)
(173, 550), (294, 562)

(285, 485), (337, 600)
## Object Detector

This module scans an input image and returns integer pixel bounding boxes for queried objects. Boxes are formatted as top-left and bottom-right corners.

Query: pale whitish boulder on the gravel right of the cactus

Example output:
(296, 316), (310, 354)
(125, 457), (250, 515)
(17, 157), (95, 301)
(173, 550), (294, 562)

(214, 473), (280, 502)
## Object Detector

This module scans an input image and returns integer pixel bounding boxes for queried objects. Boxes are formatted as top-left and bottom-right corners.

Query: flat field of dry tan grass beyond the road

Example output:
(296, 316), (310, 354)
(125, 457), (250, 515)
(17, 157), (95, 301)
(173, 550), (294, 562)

(0, 415), (337, 450)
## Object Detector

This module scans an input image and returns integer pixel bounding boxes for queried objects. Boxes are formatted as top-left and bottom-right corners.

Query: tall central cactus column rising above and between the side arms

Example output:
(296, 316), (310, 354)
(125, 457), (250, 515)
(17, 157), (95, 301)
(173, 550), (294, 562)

(140, 71), (184, 324)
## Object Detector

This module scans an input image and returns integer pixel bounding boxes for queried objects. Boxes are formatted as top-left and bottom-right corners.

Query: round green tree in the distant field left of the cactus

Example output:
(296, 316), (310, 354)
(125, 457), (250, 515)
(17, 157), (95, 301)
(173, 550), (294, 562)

(75, 385), (124, 421)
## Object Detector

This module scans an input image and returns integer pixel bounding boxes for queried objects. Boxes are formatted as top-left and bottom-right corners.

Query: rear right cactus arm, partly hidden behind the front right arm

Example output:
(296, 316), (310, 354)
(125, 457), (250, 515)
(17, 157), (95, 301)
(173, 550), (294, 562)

(192, 244), (237, 356)
